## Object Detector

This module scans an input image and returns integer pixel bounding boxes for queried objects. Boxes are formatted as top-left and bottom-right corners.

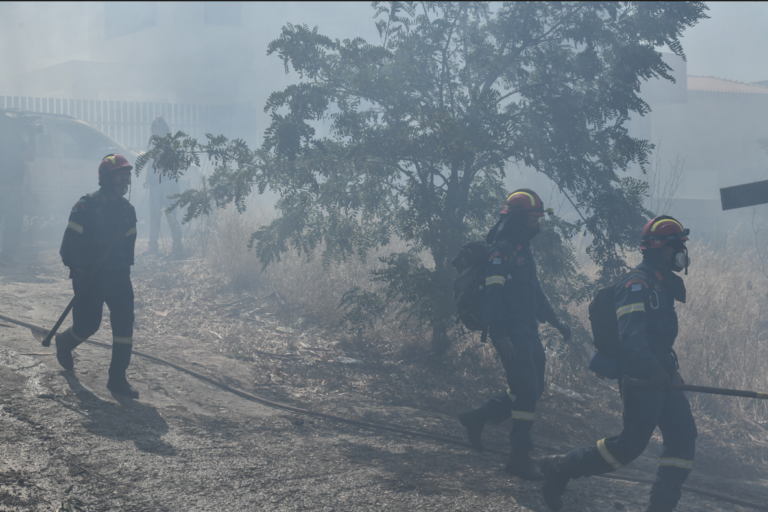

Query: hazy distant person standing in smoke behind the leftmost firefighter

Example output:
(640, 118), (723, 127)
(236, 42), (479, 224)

(144, 116), (184, 258)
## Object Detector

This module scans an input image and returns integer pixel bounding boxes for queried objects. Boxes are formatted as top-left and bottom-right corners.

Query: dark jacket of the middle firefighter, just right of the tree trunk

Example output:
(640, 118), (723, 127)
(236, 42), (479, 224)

(483, 242), (557, 345)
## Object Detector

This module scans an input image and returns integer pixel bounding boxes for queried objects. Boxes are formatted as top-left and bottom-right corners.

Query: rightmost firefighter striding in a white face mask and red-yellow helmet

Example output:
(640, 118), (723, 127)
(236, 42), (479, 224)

(541, 215), (696, 512)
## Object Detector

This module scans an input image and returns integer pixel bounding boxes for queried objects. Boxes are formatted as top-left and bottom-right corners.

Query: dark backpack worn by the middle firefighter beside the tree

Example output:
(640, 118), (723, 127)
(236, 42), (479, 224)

(451, 242), (489, 343)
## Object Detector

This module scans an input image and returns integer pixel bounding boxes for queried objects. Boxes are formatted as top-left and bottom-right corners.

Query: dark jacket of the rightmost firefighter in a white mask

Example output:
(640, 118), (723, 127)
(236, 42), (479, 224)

(615, 259), (685, 378)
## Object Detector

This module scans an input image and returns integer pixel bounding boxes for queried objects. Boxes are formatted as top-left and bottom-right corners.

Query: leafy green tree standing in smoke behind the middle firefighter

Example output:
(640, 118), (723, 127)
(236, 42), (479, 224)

(137, 2), (706, 351)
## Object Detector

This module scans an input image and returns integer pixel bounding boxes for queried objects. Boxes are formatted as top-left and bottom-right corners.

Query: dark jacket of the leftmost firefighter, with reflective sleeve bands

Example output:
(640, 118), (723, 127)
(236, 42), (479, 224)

(59, 189), (136, 277)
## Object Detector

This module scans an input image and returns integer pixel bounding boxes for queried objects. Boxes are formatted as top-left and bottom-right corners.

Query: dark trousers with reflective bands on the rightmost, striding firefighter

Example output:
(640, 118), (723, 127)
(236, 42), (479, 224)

(567, 378), (697, 506)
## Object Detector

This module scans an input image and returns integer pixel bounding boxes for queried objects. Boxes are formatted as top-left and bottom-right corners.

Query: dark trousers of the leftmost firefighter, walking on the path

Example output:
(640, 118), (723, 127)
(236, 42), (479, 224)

(67, 269), (134, 376)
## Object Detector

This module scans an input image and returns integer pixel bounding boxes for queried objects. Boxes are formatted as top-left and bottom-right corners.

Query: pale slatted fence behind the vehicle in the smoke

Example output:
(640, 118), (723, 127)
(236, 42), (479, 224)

(0, 96), (210, 150)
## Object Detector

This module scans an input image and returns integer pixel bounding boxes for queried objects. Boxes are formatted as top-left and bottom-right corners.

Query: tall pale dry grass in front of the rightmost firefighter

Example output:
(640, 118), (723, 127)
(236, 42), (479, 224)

(675, 244), (768, 421)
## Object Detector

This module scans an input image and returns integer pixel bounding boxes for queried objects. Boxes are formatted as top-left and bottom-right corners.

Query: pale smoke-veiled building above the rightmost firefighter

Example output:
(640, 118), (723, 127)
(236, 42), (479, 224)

(641, 76), (768, 236)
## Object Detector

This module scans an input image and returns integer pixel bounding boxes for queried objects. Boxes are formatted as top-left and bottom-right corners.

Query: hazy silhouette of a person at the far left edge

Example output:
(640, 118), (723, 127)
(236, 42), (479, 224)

(0, 111), (37, 265)
